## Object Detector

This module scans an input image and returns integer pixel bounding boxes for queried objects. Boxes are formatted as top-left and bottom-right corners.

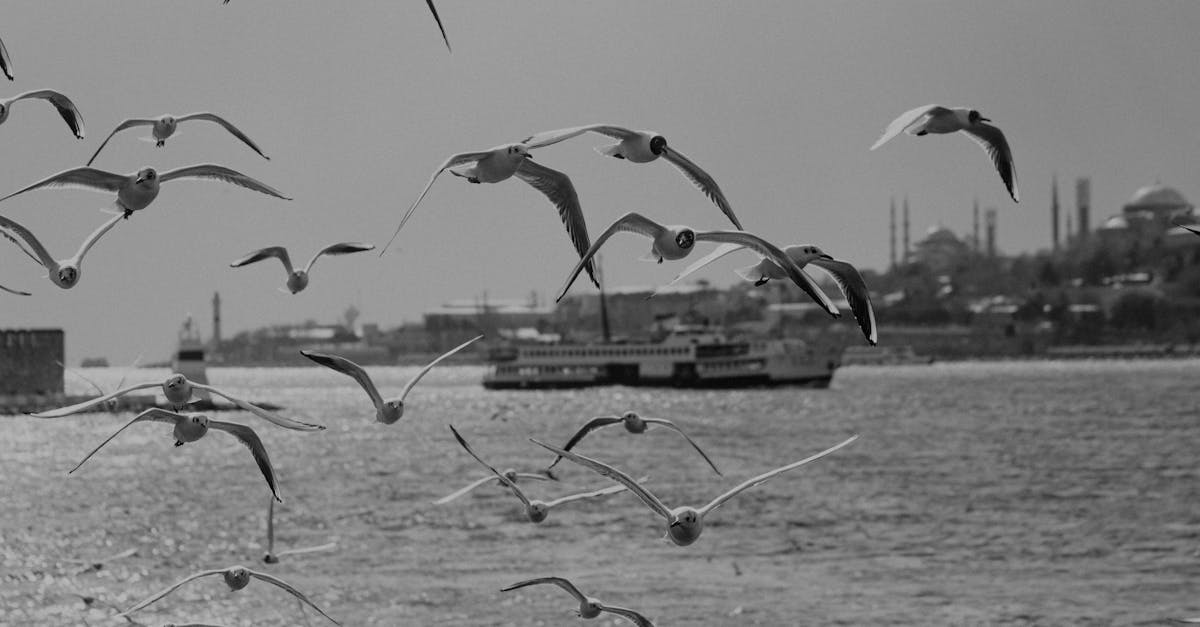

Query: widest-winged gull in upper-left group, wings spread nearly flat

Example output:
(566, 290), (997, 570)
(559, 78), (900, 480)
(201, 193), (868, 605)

(0, 163), (292, 217)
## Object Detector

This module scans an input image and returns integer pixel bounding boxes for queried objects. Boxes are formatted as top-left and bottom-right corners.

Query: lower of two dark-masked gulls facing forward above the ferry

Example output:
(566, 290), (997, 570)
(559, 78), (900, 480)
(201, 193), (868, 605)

(556, 213), (841, 318)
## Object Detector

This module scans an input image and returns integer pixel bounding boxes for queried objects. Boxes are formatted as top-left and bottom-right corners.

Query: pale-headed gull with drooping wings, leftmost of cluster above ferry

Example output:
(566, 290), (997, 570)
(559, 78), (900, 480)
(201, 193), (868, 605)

(379, 144), (600, 287)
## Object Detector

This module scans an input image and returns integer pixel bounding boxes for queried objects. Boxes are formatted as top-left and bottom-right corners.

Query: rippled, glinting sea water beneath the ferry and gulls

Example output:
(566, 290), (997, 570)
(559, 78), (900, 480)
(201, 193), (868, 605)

(0, 360), (1200, 626)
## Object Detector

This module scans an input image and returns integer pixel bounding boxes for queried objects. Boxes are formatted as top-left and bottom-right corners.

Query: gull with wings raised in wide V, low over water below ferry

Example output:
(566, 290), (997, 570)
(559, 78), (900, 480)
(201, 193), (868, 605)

(530, 435), (858, 547)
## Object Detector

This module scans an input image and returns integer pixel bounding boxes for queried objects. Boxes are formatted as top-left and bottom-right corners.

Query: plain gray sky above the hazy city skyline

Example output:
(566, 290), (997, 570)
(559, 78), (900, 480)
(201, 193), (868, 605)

(0, 0), (1200, 365)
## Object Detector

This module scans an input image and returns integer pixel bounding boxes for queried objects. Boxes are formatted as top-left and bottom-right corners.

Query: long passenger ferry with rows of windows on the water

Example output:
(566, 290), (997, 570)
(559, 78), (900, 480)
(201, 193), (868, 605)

(484, 327), (841, 389)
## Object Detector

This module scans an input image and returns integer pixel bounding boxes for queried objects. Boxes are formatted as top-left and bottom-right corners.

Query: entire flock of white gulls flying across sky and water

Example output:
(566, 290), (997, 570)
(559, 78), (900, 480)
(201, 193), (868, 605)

(0, 0), (1089, 626)
